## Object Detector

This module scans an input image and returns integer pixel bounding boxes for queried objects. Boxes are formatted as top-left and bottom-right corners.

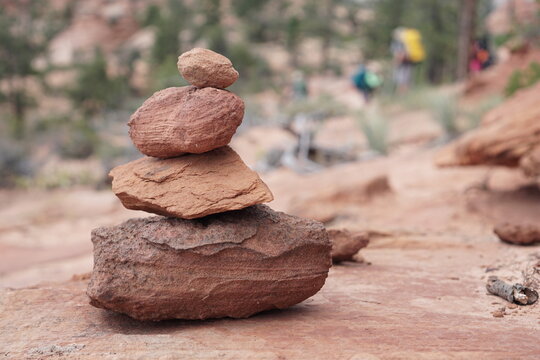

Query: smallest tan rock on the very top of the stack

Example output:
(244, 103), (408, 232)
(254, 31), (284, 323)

(177, 48), (238, 89)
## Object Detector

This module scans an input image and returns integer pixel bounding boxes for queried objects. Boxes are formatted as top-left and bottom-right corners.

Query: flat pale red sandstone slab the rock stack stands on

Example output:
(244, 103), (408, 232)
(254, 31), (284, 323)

(0, 235), (540, 360)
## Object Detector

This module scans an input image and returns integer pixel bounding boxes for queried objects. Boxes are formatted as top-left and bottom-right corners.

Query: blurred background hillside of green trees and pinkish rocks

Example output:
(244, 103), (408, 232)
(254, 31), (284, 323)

(0, 0), (540, 188)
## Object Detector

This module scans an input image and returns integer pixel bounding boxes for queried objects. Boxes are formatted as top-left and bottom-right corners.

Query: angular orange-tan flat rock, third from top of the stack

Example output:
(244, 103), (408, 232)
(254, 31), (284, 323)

(109, 146), (273, 219)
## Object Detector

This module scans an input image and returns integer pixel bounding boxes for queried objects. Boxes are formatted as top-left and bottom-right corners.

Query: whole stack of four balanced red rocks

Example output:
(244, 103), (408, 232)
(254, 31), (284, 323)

(87, 49), (331, 320)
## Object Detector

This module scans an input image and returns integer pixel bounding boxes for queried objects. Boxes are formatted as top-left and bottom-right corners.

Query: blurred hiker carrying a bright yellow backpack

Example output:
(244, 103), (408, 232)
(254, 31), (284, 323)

(390, 27), (426, 93)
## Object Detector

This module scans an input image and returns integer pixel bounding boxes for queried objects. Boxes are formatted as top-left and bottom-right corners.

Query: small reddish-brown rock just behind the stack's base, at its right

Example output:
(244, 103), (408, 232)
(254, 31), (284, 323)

(327, 229), (369, 263)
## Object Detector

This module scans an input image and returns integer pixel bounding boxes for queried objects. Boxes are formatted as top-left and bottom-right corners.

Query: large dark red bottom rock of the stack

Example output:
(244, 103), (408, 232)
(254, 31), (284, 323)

(87, 205), (331, 320)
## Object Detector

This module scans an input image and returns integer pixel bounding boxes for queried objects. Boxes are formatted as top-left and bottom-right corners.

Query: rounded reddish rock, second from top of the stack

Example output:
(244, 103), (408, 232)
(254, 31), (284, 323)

(128, 86), (244, 158)
